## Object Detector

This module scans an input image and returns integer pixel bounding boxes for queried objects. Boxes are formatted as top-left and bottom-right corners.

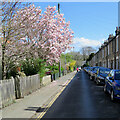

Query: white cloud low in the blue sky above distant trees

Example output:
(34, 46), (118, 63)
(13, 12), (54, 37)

(73, 37), (105, 48)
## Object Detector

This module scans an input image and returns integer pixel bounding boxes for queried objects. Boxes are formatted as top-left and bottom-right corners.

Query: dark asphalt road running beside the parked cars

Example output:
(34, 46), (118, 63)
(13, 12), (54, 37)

(43, 71), (120, 118)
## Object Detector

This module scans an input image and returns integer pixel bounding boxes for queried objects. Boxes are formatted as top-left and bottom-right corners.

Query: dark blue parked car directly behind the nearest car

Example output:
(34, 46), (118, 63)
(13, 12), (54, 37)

(94, 67), (111, 85)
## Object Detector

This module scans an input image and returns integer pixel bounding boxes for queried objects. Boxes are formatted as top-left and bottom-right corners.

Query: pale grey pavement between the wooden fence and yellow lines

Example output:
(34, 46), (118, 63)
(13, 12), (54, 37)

(2, 71), (76, 118)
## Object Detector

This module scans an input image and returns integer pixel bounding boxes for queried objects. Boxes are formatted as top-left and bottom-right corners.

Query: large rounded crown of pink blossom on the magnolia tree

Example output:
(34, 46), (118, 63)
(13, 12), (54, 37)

(13, 5), (73, 64)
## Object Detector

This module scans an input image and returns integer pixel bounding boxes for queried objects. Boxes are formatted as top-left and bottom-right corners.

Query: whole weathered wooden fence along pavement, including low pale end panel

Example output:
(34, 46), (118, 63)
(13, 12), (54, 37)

(0, 74), (51, 108)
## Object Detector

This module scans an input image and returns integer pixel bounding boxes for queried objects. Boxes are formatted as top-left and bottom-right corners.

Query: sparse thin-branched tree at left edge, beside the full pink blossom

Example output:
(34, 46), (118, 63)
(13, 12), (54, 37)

(0, 0), (27, 79)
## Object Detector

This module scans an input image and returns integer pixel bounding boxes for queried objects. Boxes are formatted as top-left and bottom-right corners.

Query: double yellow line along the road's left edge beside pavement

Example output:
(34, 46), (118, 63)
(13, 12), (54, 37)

(36, 76), (74, 120)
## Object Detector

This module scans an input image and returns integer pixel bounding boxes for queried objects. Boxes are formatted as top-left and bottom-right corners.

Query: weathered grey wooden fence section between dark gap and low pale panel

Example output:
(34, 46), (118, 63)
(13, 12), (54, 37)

(15, 74), (40, 98)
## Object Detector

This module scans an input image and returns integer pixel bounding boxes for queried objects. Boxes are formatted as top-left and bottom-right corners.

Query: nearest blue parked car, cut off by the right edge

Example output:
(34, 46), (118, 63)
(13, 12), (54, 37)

(104, 70), (120, 101)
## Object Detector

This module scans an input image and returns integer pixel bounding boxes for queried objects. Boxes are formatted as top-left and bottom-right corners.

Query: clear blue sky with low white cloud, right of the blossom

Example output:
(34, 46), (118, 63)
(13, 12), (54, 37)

(34, 2), (118, 51)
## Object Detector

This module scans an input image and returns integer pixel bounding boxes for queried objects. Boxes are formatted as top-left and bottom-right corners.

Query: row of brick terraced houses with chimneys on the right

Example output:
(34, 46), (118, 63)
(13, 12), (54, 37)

(89, 27), (120, 69)
